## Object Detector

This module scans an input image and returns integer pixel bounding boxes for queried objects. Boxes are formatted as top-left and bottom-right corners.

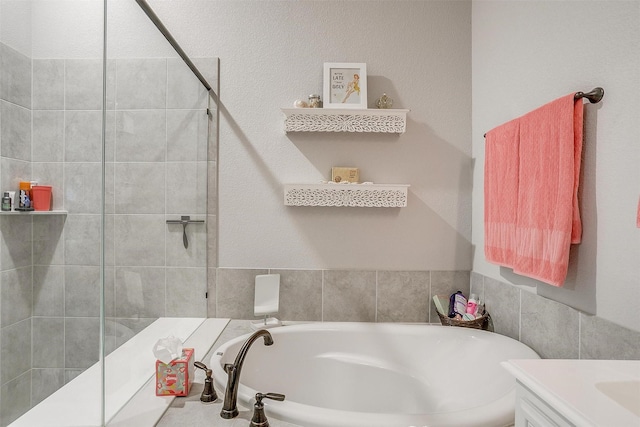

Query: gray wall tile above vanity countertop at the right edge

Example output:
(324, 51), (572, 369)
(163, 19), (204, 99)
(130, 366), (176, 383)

(580, 313), (640, 360)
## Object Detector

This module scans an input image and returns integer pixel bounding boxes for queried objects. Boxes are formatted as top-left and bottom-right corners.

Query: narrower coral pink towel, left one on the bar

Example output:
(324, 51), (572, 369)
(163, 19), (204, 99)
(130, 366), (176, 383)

(484, 119), (520, 267)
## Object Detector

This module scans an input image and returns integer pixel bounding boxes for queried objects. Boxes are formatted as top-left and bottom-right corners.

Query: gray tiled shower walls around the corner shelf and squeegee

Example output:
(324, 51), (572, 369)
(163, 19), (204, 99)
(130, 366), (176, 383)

(0, 45), (217, 426)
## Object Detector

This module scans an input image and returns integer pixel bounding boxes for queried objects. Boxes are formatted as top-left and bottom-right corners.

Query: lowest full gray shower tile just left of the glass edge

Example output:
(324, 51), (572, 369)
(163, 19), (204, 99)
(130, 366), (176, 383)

(64, 317), (100, 369)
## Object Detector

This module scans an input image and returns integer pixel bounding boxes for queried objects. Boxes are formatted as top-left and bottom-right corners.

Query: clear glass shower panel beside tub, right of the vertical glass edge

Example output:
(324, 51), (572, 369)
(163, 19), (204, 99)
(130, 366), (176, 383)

(105, 0), (212, 422)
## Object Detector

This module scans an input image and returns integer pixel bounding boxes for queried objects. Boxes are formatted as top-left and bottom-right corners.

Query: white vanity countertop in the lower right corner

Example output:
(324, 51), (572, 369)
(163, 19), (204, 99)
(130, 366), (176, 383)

(502, 359), (640, 427)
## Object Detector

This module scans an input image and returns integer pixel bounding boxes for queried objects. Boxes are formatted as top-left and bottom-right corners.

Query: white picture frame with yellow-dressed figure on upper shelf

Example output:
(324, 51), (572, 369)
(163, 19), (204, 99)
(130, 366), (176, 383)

(322, 62), (367, 110)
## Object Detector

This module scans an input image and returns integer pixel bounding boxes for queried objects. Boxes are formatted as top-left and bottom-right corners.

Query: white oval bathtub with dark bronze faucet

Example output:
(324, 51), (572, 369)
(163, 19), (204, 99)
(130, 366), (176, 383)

(211, 323), (539, 427)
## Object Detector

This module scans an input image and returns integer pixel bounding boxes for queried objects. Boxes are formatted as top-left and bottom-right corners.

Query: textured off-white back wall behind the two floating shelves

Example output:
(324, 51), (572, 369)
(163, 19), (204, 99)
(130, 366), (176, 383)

(150, 0), (471, 270)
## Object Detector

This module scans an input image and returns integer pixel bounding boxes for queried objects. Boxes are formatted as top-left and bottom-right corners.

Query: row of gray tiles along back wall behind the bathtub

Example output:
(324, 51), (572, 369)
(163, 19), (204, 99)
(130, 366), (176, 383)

(208, 268), (469, 323)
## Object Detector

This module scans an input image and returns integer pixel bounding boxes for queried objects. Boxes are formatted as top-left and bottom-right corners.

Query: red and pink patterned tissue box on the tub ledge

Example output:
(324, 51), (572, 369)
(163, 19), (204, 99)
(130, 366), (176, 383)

(156, 348), (195, 396)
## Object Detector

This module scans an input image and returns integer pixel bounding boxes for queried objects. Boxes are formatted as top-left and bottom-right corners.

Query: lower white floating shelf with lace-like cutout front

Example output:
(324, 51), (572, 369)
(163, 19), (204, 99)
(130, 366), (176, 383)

(284, 183), (409, 208)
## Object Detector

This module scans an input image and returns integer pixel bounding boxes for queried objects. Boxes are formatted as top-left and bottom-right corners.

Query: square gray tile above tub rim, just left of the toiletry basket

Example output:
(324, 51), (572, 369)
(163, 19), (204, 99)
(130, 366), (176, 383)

(377, 271), (431, 322)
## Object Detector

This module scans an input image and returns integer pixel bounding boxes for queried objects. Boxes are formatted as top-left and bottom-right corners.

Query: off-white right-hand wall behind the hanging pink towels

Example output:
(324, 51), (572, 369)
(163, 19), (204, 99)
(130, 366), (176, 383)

(473, 0), (640, 330)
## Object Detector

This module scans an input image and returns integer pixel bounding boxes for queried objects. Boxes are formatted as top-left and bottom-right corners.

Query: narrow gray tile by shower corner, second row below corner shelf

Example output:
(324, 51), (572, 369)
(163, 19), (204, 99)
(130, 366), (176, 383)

(33, 265), (65, 317)
